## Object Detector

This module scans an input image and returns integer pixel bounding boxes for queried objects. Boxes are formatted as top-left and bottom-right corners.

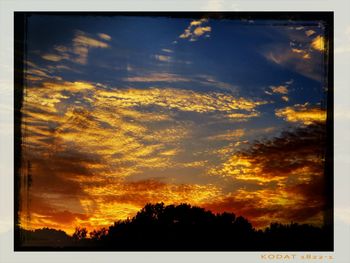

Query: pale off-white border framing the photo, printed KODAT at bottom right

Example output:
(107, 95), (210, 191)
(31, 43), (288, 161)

(0, 0), (350, 263)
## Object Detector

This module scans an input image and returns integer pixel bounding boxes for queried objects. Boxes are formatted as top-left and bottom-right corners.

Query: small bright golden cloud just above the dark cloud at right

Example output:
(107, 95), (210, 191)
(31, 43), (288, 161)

(275, 103), (327, 125)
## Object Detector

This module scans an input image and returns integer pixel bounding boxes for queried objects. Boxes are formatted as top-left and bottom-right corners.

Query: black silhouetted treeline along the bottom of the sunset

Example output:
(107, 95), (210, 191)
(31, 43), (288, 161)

(19, 203), (333, 251)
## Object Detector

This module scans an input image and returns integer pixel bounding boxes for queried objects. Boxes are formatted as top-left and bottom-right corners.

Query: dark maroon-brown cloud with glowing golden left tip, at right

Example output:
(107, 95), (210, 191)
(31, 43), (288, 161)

(212, 123), (325, 183)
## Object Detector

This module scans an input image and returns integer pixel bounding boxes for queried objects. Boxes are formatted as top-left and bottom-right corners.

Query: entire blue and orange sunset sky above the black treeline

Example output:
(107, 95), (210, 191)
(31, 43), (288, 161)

(19, 15), (327, 234)
